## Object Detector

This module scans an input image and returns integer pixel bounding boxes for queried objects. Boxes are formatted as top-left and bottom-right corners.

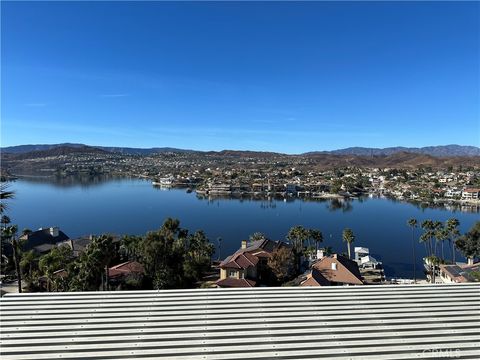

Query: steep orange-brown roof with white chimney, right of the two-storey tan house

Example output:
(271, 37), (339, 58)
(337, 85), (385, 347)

(312, 254), (363, 285)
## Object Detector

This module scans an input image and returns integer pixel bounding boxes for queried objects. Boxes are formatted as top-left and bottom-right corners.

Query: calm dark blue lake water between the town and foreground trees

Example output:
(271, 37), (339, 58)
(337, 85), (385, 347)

(7, 179), (480, 277)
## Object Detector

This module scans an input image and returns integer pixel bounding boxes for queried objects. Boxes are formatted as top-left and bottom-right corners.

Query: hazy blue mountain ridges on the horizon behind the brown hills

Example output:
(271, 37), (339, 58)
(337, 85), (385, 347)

(1, 143), (480, 157)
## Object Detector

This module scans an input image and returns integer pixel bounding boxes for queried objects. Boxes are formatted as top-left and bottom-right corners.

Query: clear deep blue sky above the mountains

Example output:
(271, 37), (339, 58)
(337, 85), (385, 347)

(1, 1), (480, 153)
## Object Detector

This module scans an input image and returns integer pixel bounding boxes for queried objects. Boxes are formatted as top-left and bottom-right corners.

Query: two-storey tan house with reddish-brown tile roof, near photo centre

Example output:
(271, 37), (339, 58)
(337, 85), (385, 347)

(216, 239), (289, 287)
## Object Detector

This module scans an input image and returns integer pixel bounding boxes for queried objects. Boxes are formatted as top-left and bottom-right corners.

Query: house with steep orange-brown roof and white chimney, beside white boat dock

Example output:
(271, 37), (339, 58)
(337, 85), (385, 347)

(300, 254), (363, 286)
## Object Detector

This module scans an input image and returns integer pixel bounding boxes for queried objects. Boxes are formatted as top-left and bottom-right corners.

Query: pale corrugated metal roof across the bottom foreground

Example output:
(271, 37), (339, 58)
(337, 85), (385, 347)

(0, 284), (480, 360)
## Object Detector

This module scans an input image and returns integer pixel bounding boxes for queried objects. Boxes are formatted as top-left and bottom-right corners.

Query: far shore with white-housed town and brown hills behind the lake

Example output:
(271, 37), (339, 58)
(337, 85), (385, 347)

(1, 144), (480, 212)
